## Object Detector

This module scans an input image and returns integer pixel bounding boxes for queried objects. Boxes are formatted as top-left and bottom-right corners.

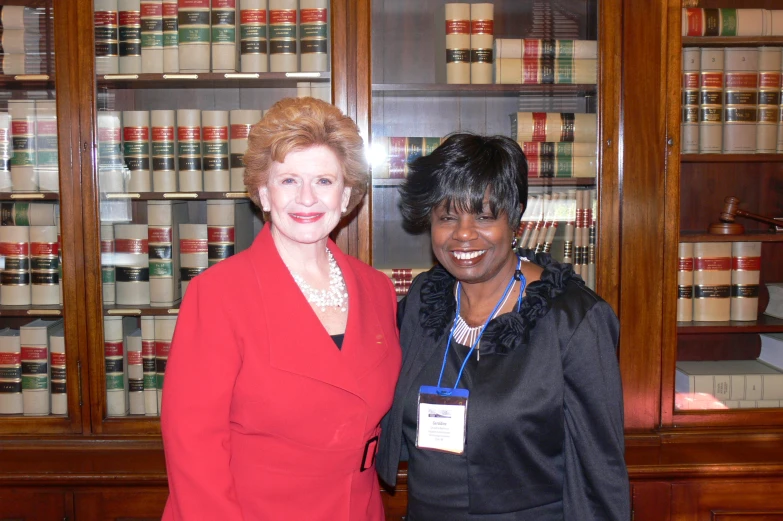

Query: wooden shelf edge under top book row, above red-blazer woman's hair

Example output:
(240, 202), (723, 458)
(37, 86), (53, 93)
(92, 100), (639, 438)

(97, 72), (331, 89)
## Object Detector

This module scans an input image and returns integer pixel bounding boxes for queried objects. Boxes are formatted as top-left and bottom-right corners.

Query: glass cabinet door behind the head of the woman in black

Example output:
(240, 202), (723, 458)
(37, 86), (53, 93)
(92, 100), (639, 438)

(370, 0), (601, 295)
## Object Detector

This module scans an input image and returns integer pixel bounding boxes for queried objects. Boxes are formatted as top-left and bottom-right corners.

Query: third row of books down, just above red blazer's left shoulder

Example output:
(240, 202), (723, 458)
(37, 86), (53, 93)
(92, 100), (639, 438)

(100, 199), (254, 307)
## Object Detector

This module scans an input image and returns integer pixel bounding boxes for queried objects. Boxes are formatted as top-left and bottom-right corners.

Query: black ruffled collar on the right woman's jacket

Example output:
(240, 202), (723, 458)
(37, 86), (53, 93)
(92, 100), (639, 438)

(419, 250), (584, 354)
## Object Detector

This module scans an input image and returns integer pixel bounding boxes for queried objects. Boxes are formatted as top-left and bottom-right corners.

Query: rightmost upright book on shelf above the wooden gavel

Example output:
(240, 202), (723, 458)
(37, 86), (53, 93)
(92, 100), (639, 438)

(756, 47), (783, 154)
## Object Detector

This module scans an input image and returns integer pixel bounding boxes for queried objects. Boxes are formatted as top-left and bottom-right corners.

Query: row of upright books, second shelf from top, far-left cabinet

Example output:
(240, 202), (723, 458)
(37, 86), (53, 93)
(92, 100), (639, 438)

(0, 100), (60, 193)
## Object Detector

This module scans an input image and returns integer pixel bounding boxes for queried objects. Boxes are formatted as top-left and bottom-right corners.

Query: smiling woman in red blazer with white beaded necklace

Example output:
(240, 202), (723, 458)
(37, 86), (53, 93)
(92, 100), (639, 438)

(161, 98), (400, 521)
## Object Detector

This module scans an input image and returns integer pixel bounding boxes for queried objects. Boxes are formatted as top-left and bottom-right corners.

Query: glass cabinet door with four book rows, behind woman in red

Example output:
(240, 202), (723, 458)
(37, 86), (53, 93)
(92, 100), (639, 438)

(86, 0), (345, 433)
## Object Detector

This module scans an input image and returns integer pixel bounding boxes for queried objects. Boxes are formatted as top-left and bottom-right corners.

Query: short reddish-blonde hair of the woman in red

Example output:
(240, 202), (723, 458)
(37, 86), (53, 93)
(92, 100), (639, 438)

(244, 97), (369, 213)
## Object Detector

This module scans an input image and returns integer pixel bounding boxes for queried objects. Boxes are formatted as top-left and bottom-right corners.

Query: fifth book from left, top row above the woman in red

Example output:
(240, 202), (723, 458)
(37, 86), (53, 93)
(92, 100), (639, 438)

(177, 0), (211, 73)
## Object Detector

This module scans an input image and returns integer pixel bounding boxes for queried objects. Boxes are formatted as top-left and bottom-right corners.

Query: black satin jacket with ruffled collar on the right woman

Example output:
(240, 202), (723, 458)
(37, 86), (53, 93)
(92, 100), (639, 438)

(376, 251), (630, 521)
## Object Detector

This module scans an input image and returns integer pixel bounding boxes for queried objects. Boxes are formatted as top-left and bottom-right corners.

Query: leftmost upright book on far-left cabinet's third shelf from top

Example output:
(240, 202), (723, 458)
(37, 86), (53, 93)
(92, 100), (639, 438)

(0, 226), (32, 306)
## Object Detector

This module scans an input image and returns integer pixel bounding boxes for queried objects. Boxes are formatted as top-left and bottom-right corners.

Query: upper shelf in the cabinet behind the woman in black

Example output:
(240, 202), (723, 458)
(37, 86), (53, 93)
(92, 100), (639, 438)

(372, 83), (597, 96)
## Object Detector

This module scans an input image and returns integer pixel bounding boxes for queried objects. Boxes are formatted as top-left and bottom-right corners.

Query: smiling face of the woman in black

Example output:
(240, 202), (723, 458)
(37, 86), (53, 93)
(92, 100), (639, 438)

(430, 196), (516, 284)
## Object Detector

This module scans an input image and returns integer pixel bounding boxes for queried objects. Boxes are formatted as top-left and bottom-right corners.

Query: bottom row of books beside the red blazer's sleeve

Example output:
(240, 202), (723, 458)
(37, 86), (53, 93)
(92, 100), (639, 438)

(103, 315), (177, 417)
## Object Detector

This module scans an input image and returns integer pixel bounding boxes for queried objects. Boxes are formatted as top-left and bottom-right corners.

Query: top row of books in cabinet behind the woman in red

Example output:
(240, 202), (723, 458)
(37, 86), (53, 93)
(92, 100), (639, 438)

(93, 0), (329, 75)
